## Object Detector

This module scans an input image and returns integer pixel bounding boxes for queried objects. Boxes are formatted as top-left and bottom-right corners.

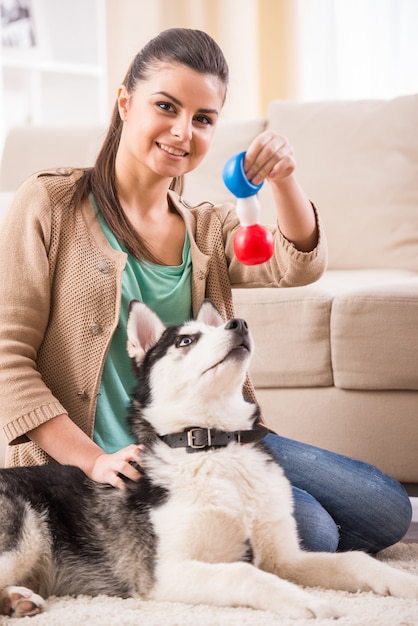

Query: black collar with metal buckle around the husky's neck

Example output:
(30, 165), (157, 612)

(160, 424), (269, 452)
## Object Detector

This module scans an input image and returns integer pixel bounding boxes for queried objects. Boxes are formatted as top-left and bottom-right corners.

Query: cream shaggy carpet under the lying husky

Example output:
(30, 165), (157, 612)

(0, 543), (418, 626)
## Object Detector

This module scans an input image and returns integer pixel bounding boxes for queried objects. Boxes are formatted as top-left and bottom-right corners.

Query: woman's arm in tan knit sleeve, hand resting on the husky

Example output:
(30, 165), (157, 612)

(0, 176), (140, 487)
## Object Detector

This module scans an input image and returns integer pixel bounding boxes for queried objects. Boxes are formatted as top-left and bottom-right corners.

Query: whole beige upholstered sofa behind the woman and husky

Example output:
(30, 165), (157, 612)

(0, 96), (418, 493)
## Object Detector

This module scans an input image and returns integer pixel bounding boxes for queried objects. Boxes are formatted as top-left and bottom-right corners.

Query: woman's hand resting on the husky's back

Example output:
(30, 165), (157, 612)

(89, 444), (144, 489)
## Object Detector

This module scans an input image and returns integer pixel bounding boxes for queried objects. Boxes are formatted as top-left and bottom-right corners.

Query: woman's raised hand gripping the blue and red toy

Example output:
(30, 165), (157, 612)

(244, 130), (296, 185)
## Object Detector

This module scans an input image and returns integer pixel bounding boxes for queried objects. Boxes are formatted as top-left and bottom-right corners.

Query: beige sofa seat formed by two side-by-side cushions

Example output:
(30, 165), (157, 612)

(234, 270), (418, 391)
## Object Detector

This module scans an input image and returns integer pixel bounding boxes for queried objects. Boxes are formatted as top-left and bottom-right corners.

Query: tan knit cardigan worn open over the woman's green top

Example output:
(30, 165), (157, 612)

(0, 168), (326, 465)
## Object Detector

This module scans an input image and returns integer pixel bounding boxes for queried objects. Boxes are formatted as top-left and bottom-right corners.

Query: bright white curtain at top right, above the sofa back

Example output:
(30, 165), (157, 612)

(296, 0), (418, 100)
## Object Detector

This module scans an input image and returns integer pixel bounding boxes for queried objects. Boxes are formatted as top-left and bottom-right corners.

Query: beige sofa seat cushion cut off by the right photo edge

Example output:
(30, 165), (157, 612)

(319, 270), (418, 390)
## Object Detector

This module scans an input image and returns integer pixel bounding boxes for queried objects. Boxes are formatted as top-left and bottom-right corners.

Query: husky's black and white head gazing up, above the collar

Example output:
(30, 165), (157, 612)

(127, 301), (254, 434)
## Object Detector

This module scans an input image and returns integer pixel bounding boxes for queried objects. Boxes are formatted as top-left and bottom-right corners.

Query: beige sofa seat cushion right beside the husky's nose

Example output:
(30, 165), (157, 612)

(233, 285), (333, 388)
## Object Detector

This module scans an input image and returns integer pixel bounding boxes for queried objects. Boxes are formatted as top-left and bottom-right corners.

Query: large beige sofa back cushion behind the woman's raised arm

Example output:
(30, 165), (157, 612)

(260, 95), (418, 270)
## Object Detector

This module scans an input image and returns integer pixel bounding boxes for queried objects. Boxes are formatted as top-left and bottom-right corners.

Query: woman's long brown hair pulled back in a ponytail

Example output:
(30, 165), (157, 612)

(74, 28), (228, 262)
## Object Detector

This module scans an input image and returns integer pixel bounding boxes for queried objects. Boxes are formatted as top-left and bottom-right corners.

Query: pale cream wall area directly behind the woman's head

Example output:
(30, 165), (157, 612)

(106, 0), (259, 119)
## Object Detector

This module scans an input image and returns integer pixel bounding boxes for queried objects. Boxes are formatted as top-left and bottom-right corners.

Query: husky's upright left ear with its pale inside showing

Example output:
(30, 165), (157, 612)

(126, 300), (165, 360)
